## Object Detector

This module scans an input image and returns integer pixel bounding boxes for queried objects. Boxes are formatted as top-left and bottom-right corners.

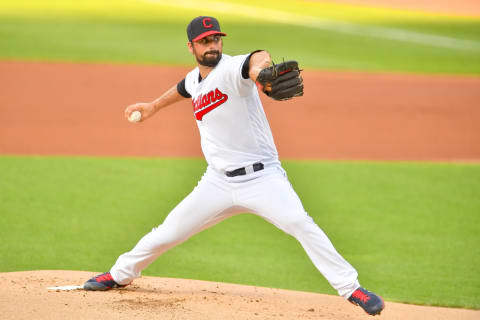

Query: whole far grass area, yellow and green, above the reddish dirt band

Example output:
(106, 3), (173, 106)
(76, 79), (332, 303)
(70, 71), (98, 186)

(0, 0), (480, 74)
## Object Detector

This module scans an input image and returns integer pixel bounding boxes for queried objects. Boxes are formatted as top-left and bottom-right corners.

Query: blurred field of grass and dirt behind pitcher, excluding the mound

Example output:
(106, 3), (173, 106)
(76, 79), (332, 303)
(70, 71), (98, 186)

(0, 0), (480, 309)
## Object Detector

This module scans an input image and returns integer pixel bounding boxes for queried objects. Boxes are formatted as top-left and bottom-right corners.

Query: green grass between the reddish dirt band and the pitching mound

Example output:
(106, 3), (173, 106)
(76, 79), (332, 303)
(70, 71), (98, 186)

(0, 156), (480, 309)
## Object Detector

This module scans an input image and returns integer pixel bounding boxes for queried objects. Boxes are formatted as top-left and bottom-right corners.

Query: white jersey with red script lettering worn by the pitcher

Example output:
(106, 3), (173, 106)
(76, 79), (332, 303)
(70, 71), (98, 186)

(185, 54), (279, 172)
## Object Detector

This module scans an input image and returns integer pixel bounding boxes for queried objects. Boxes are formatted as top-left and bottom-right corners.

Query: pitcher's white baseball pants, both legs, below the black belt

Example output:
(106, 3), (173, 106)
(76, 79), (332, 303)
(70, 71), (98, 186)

(110, 165), (360, 298)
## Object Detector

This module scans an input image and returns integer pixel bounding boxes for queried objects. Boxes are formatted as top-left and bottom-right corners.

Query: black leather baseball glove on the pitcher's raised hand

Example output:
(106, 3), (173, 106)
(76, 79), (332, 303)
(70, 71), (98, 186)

(256, 60), (303, 100)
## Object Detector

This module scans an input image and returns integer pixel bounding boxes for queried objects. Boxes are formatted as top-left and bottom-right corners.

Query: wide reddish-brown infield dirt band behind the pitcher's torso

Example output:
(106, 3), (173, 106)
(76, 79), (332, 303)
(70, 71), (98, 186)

(0, 62), (480, 161)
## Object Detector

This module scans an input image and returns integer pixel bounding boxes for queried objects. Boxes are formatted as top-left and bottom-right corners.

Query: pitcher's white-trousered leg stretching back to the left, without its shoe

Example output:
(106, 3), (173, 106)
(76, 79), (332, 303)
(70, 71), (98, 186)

(87, 171), (235, 285)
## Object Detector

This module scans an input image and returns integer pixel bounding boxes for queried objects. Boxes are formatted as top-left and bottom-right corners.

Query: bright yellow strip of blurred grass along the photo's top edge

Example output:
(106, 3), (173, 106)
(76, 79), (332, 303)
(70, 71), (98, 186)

(0, 0), (479, 23)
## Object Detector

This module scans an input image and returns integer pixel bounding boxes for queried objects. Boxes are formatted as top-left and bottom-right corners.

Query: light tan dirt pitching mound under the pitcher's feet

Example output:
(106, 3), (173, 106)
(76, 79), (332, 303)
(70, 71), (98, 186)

(0, 271), (480, 320)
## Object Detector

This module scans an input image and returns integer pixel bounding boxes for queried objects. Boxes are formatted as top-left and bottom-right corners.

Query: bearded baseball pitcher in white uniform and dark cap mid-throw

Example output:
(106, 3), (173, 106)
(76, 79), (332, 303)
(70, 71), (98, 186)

(84, 16), (384, 315)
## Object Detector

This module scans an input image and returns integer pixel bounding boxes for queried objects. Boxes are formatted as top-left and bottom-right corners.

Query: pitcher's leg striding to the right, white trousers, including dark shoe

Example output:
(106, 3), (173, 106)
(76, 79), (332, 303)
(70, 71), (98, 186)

(237, 169), (383, 314)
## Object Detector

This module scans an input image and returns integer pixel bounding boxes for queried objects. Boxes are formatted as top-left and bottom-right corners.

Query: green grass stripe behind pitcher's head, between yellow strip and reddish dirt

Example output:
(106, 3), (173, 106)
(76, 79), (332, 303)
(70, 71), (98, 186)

(0, 19), (480, 74)
